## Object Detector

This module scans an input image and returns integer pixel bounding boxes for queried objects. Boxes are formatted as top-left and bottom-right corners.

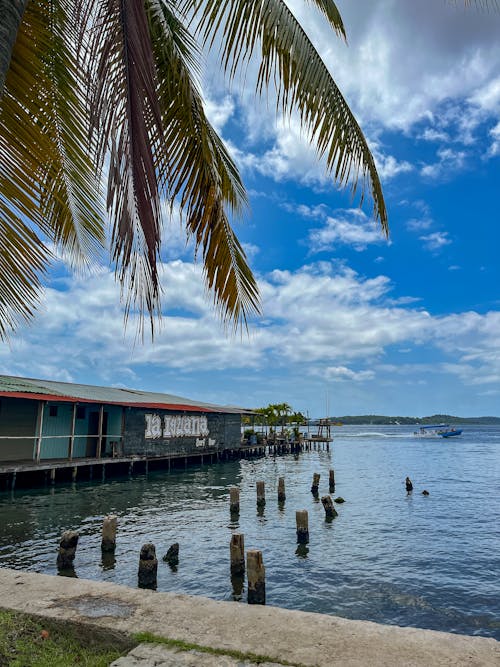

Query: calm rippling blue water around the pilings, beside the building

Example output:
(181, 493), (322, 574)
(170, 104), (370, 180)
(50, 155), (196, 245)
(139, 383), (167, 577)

(0, 426), (500, 639)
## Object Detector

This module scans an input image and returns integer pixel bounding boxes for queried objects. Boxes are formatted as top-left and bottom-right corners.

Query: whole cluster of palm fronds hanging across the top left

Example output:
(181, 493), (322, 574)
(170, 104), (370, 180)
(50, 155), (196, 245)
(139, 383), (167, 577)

(0, 0), (492, 338)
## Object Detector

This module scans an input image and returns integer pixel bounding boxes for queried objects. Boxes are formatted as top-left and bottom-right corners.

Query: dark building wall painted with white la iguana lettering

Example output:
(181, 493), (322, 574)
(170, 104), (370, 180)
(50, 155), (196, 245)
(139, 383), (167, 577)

(123, 408), (241, 456)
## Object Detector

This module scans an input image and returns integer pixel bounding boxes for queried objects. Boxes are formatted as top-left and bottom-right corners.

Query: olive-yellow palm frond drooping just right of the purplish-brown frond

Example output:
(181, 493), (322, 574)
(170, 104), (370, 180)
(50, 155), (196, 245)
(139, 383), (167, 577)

(151, 3), (259, 327)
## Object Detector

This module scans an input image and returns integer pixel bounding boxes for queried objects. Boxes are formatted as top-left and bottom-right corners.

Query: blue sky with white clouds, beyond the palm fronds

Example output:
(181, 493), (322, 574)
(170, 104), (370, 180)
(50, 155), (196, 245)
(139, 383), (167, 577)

(0, 0), (500, 416)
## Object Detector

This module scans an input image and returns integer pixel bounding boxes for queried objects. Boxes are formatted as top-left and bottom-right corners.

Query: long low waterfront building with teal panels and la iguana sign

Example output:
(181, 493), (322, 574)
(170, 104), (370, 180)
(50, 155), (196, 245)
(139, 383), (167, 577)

(0, 375), (248, 465)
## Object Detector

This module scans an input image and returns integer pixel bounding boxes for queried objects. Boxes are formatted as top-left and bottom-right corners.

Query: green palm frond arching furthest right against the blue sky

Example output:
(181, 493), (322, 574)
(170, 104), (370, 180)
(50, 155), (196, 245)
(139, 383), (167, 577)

(183, 0), (388, 234)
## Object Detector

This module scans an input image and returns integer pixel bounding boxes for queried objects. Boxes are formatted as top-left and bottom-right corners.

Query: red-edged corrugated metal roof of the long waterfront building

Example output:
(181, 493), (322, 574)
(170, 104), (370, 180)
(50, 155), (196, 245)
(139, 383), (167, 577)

(0, 375), (250, 414)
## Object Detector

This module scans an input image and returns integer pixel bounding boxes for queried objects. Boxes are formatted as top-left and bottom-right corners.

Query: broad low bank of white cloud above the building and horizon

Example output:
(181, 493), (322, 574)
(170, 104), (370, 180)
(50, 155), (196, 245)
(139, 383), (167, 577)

(0, 260), (500, 414)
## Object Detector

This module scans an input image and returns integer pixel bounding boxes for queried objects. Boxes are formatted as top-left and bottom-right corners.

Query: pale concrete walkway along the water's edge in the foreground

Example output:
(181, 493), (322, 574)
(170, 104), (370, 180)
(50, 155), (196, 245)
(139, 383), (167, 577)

(0, 569), (500, 667)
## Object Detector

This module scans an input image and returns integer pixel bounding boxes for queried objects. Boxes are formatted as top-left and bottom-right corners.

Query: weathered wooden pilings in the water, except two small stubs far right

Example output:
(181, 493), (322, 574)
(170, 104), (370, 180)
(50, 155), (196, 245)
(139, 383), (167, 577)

(57, 469), (344, 604)
